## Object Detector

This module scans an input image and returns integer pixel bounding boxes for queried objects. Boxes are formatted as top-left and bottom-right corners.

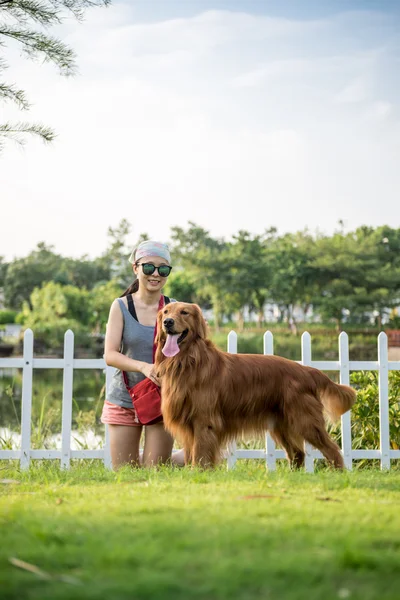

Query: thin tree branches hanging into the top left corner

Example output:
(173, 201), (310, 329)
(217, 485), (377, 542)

(0, 0), (110, 151)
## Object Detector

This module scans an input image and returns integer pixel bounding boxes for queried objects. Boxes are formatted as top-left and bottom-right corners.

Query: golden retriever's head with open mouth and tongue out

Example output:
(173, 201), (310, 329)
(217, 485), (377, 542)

(157, 302), (207, 358)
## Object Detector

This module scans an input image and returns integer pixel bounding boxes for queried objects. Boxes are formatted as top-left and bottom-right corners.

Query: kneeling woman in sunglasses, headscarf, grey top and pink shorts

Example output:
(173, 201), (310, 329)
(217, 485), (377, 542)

(101, 241), (183, 469)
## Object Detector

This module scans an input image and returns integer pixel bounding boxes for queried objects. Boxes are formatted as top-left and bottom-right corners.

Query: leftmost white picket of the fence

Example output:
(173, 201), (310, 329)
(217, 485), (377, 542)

(20, 329), (33, 470)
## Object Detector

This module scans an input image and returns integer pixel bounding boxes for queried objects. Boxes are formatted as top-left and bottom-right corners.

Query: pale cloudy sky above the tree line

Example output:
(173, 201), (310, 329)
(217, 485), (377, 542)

(0, 0), (400, 260)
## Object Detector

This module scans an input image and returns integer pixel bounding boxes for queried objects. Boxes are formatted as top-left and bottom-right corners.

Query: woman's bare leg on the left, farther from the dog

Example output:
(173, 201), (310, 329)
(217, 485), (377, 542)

(108, 425), (142, 469)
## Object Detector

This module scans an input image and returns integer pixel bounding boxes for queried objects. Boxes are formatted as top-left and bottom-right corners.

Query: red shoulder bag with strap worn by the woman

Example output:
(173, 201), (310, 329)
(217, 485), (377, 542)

(122, 296), (164, 425)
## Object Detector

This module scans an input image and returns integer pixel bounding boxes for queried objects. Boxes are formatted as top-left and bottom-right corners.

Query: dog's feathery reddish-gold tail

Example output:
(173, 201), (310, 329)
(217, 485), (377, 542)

(312, 369), (357, 421)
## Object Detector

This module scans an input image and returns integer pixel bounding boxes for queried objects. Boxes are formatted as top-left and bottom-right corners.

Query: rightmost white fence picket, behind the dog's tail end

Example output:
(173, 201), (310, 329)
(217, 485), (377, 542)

(378, 331), (390, 469)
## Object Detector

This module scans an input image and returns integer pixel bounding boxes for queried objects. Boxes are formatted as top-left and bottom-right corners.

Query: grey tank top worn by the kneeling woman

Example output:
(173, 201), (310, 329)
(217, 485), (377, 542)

(106, 298), (176, 408)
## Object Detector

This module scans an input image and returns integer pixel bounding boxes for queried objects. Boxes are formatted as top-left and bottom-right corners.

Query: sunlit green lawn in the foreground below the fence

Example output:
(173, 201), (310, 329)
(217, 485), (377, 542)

(0, 461), (400, 600)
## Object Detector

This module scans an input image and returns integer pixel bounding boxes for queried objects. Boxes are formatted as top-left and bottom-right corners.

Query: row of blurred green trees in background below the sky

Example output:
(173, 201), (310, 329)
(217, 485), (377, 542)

(0, 219), (400, 334)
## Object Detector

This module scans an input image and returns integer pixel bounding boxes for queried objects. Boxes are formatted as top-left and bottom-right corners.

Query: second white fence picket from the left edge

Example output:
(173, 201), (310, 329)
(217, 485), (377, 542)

(61, 329), (74, 469)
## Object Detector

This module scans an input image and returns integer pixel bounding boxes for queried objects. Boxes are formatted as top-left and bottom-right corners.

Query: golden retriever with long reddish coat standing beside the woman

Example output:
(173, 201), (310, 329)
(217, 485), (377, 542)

(155, 302), (356, 468)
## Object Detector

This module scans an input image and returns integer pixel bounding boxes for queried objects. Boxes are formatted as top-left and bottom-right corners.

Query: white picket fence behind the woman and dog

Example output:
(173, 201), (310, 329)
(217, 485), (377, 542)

(0, 329), (400, 472)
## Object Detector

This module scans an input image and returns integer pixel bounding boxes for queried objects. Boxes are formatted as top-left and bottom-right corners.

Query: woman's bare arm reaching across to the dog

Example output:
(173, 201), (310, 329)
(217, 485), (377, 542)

(104, 300), (159, 385)
